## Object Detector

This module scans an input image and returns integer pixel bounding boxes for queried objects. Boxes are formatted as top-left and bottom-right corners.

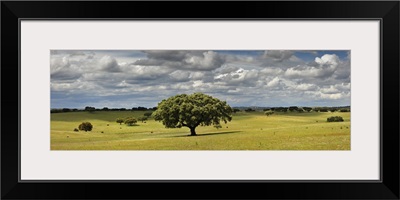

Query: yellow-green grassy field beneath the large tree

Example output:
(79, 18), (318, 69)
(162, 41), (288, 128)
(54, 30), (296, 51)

(51, 111), (350, 150)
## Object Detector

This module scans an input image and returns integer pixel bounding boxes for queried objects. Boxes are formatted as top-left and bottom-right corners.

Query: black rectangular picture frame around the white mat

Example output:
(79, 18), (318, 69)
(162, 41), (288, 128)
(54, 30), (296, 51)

(1, 1), (400, 199)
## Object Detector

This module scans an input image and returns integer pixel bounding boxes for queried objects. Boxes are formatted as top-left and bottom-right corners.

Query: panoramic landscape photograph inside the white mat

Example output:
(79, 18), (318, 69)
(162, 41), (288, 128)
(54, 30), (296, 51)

(50, 49), (351, 150)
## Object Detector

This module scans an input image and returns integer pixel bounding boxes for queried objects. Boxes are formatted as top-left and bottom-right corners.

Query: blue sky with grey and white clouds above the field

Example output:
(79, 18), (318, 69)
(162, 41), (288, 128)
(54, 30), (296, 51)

(50, 50), (350, 108)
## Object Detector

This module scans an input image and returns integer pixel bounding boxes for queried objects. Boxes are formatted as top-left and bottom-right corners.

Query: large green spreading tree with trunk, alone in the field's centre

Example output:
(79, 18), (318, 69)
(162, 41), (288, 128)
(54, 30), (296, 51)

(152, 93), (233, 136)
